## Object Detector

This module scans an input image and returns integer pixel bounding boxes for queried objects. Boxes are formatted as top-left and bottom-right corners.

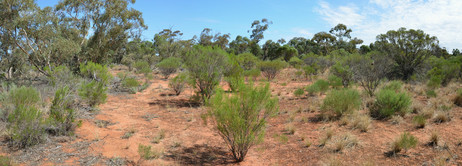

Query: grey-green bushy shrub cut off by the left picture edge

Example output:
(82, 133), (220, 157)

(1, 86), (44, 148)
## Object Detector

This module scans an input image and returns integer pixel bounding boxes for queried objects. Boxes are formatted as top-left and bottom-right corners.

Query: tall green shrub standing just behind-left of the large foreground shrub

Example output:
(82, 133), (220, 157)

(184, 46), (228, 101)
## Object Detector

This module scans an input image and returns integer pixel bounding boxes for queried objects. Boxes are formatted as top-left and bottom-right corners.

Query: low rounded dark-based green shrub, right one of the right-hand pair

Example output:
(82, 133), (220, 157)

(370, 89), (412, 119)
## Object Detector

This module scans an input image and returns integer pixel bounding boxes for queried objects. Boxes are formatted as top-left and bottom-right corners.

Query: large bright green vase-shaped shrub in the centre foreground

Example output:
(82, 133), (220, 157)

(209, 82), (278, 162)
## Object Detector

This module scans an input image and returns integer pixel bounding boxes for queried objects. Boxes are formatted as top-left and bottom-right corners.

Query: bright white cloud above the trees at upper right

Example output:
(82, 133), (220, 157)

(317, 0), (462, 51)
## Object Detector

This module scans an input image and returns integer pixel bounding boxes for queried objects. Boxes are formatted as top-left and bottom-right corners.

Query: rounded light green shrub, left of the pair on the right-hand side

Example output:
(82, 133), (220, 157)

(321, 89), (361, 119)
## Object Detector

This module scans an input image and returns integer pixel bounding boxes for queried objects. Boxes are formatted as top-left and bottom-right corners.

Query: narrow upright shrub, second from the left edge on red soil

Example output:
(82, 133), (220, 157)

(47, 87), (76, 135)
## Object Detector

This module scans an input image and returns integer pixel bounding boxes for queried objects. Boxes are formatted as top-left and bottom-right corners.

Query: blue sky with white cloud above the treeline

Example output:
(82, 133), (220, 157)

(36, 0), (462, 52)
